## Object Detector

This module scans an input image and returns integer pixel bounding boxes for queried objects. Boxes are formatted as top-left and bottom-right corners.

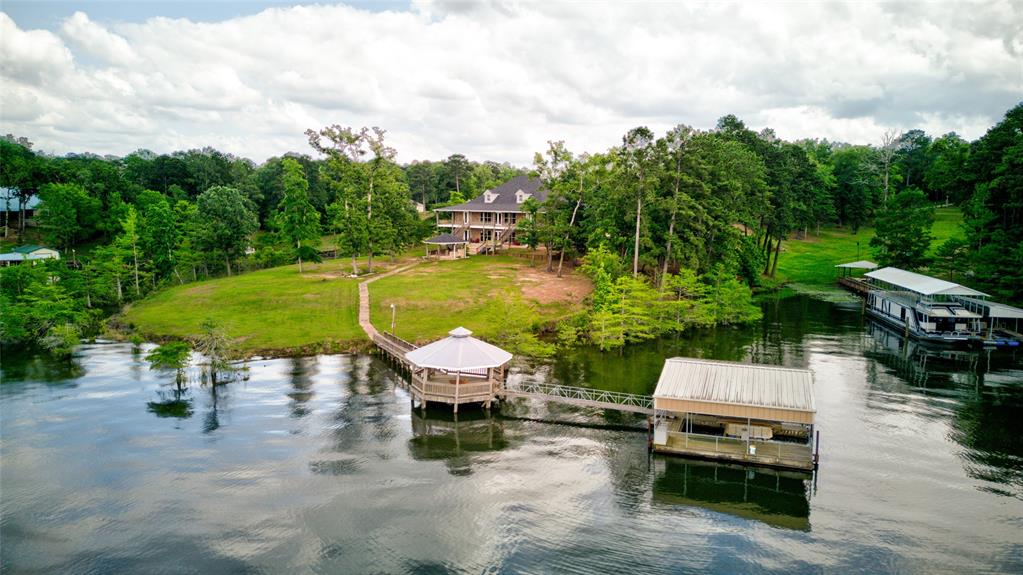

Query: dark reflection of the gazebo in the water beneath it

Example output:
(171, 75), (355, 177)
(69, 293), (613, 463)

(408, 410), (508, 475)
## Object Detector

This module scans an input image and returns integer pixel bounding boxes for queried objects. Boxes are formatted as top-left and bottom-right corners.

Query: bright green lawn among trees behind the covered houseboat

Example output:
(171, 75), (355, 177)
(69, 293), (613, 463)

(776, 207), (963, 286)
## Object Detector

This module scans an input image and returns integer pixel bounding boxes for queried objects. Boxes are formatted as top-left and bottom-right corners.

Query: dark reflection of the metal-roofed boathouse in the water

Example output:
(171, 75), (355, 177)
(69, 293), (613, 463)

(653, 455), (811, 531)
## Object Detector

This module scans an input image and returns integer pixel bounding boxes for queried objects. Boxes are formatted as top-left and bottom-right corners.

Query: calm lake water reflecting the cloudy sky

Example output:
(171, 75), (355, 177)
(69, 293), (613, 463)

(0, 296), (1023, 573)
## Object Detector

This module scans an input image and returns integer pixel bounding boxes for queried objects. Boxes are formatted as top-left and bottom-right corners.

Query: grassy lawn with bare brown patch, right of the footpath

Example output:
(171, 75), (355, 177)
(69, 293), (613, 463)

(369, 255), (589, 343)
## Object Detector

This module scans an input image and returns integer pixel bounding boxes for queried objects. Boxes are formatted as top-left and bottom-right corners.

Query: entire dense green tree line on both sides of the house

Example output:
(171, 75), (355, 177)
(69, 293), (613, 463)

(0, 104), (1023, 349)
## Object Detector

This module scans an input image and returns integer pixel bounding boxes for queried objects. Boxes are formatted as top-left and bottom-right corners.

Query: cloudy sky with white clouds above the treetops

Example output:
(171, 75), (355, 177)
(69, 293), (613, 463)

(0, 0), (1023, 166)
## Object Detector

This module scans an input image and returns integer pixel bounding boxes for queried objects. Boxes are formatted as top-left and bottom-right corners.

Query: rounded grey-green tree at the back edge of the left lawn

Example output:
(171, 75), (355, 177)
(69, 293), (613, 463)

(195, 186), (259, 275)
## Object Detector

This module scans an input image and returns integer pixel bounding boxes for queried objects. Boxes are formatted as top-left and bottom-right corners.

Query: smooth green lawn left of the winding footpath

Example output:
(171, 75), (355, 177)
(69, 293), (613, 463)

(120, 261), (365, 355)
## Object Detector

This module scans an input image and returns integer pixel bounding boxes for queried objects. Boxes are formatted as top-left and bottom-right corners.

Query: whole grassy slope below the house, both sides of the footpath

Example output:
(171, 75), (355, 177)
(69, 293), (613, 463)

(117, 250), (590, 355)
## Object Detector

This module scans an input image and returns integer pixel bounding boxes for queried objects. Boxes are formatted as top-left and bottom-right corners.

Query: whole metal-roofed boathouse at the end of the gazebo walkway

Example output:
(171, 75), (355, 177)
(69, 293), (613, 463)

(654, 357), (816, 470)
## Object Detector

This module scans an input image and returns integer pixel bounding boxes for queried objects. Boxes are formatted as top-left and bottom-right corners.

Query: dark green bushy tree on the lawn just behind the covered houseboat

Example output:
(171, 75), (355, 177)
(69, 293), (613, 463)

(871, 188), (934, 269)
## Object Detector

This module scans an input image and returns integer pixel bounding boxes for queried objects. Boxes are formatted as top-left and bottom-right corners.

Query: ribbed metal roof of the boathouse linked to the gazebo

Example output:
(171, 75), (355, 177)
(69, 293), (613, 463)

(654, 357), (816, 423)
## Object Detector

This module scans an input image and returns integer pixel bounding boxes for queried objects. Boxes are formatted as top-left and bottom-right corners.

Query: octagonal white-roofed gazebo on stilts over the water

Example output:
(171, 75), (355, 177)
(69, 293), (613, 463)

(405, 327), (512, 413)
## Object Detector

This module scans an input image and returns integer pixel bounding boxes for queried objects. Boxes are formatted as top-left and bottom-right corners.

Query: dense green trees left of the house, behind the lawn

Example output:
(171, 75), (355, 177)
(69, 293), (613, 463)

(0, 130), (432, 351)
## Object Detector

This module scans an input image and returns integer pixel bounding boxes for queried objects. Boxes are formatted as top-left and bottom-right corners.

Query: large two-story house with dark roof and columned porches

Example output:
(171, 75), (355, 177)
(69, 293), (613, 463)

(434, 176), (547, 247)
